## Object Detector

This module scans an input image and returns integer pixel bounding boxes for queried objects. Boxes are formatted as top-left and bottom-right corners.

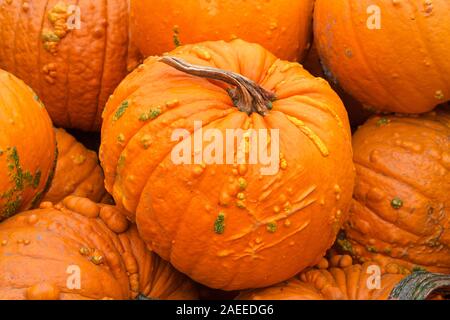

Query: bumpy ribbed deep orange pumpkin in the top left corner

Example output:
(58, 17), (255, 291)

(0, 0), (139, 130)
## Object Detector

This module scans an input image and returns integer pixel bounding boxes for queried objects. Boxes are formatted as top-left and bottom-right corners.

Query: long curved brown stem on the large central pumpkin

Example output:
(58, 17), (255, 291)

(159, 56), (276, 116)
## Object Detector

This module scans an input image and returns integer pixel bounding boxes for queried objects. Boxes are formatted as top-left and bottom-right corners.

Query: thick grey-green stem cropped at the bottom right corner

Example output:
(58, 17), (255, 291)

(389, 271), (450, 300)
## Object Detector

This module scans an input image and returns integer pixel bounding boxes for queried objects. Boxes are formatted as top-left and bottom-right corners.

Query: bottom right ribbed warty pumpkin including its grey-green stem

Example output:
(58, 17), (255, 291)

(236, 255), (450, 300)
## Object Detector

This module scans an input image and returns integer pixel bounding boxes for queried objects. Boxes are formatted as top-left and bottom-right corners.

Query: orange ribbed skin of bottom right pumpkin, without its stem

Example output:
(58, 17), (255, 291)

(237, 255), (405, 300)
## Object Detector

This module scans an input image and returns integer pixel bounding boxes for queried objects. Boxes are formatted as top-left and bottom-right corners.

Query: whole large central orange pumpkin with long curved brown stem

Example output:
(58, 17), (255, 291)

(100, 40), (354, 290)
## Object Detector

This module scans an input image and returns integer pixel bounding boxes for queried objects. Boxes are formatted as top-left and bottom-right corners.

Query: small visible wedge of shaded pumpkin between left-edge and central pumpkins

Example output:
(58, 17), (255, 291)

(43, 129), (109, 203)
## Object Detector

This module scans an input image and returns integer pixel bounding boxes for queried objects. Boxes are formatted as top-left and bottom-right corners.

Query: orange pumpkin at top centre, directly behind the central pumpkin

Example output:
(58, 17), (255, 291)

(130, 0), (314, 61)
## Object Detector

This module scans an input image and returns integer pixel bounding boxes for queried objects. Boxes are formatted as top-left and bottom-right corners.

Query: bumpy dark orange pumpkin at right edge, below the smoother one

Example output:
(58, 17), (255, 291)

(338, 109), (450, 273)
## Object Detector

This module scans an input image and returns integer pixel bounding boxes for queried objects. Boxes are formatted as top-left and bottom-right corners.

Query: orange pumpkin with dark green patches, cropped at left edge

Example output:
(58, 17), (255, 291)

(0, 69), (56, 221)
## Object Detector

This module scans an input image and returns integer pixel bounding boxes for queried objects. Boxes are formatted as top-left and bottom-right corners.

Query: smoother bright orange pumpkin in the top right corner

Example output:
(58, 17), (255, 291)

(314, 0), (450, 113)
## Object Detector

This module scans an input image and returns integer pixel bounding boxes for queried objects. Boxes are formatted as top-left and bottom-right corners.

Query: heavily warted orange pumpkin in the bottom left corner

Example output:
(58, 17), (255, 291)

(0, 196), (197, 300)
